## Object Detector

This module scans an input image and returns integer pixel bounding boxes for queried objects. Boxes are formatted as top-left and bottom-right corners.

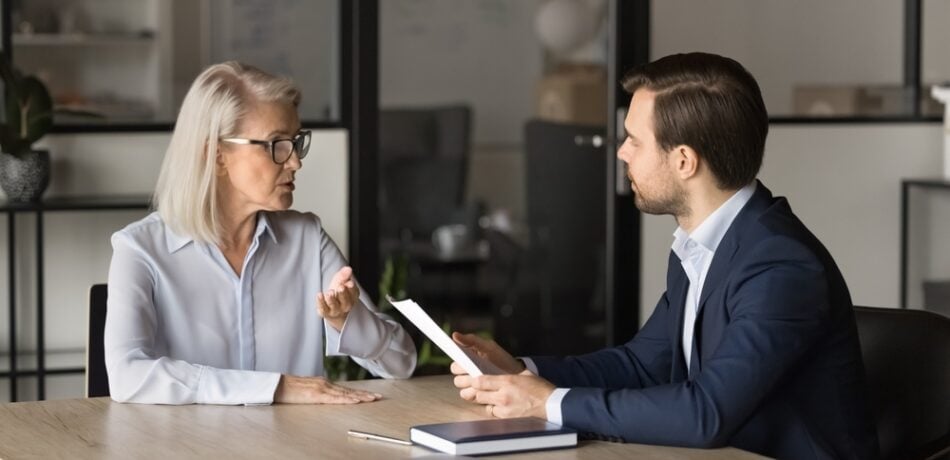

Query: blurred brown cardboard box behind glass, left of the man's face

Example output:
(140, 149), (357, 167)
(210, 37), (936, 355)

(537, 64), (607, 125)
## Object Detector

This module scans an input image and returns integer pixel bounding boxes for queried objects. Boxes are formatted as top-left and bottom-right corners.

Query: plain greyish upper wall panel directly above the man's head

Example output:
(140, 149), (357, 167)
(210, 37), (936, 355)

(650, 0), (908, 115)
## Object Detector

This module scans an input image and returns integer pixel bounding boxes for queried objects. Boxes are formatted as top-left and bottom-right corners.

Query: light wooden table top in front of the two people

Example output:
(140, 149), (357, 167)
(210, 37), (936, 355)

(0, 376), (760, 460)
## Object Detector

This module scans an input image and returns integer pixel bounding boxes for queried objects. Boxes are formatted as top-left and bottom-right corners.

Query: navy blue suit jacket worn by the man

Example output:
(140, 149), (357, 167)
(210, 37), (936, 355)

(533, 183), (878, 459)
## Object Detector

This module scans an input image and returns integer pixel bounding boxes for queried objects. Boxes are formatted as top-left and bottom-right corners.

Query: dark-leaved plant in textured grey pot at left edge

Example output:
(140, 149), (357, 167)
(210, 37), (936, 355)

(0, 52), (53, 202)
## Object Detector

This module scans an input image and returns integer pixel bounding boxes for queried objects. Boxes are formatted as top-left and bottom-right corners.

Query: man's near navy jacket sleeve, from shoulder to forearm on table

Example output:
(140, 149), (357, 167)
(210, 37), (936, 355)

(562, 236), (830, 447)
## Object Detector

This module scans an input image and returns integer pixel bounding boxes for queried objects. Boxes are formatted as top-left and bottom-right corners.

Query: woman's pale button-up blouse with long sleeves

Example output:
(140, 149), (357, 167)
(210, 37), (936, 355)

(105, 211), (416, 404)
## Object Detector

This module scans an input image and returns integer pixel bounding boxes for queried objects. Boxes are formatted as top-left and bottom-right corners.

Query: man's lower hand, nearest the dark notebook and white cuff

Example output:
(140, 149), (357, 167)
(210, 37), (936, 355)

(454, 370), (555, 419)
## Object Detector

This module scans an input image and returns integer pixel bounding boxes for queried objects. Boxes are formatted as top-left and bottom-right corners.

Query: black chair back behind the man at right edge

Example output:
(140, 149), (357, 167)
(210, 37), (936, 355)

(854, 307), (950, 459)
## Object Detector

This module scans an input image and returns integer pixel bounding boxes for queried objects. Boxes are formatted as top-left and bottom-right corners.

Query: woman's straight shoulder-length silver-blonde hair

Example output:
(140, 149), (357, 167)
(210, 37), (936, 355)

(153, 61), (300, 243)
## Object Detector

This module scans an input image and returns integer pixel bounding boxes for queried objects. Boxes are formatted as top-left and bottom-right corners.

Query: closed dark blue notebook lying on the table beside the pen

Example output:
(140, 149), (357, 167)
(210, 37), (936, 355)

(409, 417), (577, 455)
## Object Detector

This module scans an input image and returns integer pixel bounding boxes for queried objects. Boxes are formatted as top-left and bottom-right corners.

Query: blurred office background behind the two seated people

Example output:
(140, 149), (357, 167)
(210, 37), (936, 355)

(0, 0), (950, 400)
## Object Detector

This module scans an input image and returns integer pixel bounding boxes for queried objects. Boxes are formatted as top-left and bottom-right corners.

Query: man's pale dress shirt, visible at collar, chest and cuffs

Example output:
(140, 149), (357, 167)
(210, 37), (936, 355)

(536, 181), (756, 425)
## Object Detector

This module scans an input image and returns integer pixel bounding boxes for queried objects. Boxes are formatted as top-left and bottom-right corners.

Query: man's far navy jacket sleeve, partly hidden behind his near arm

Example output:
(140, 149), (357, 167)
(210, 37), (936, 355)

(531, 293), (673, 389)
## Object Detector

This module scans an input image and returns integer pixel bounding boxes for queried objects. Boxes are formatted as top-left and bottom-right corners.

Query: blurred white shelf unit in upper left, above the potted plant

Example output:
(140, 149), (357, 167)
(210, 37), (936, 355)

(12, 0), (173, 123)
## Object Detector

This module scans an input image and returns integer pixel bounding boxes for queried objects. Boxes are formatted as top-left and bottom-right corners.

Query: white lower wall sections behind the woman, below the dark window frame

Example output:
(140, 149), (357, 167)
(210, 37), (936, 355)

(0, 130), (349, 400)
